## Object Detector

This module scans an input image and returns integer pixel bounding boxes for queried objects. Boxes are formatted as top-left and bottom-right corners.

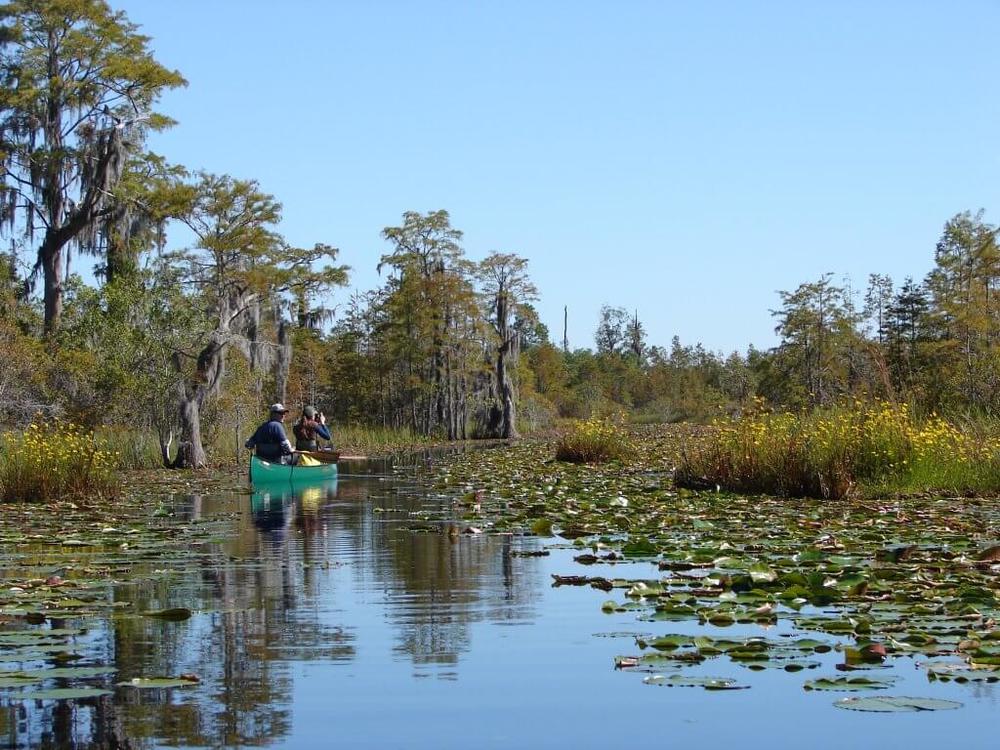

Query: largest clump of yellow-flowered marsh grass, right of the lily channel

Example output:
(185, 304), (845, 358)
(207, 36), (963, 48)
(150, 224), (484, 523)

(675, 402), (1000, 498)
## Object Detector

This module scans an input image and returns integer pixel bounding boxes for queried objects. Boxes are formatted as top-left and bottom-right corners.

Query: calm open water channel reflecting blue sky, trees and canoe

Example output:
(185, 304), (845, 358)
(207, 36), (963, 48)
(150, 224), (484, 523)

(0, 466), (1000, 750)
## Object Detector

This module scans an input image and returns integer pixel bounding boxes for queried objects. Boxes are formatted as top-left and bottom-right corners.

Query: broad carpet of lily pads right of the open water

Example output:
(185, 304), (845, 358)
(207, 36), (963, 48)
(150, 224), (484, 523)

(437, 434), (1000, 710)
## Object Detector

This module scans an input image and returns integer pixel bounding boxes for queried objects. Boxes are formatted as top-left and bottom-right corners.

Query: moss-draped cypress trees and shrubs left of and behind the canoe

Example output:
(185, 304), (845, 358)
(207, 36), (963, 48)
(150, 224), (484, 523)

(0, 0), (535, 466)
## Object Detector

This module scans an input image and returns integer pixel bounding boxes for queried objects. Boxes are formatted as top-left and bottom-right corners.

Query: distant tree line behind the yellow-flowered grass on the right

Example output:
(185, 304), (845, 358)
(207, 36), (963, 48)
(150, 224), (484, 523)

(527, 210), (1000, 421)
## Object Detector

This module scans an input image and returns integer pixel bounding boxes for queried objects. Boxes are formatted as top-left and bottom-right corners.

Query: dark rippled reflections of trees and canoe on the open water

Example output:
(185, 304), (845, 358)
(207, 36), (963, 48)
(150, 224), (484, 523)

(0, 470), (533, 750)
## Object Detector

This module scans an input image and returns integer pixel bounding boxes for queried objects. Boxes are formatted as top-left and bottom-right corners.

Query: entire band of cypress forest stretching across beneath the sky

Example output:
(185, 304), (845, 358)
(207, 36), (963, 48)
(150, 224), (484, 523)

(0, 0), (1000, 467)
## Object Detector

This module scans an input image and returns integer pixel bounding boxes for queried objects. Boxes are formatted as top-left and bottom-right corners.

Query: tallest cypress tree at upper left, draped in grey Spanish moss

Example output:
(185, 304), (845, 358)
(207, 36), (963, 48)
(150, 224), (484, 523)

(0, 0), (185, 333)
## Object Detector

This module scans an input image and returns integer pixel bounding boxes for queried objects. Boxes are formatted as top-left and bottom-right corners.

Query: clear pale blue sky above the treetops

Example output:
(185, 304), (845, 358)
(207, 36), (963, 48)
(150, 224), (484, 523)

(111, 0), (1000, 352)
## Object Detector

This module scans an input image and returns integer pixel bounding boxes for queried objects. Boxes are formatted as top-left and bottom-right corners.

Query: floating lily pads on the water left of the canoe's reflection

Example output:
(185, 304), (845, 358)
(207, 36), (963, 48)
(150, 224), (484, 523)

(0, 482), (244, 700)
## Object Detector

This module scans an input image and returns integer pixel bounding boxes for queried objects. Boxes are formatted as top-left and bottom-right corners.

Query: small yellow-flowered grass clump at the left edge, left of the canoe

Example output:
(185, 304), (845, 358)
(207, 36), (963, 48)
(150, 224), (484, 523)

(0, 420), (121, 502)
